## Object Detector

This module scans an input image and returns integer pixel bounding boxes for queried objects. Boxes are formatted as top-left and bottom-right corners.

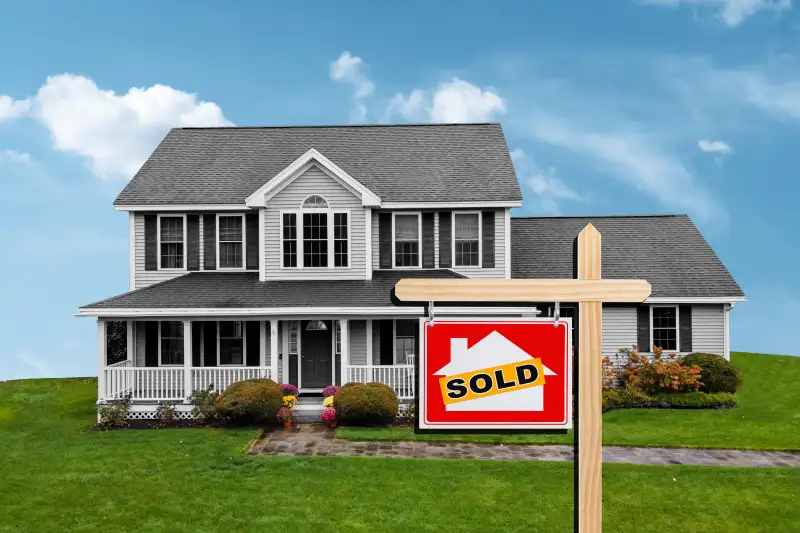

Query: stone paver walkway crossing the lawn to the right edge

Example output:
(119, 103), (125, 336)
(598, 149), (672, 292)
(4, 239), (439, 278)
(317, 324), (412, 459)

(247, 424), (800, 467)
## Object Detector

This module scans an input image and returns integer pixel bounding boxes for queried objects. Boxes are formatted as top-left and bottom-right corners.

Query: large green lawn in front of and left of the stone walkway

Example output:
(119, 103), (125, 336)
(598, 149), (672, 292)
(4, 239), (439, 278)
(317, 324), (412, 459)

(0, 380), (800, 533)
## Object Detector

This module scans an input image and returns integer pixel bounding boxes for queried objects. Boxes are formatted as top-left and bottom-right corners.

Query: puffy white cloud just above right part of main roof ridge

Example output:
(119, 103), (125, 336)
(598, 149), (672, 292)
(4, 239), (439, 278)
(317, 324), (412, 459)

(386, 78), (506, 123)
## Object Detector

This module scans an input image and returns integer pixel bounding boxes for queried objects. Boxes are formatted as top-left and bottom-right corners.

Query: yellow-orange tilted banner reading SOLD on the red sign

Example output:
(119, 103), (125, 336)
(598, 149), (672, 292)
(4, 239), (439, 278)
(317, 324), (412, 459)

(439, 358), (544, 405)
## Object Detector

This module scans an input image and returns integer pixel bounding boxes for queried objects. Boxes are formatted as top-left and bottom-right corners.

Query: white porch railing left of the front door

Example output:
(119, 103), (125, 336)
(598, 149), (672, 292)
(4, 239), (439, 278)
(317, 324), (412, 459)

(102, 361), (270, 401)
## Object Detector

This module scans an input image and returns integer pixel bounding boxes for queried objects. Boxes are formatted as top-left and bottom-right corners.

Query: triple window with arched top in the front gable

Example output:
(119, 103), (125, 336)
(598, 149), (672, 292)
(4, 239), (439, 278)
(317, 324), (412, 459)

(281, 194), (350, 268)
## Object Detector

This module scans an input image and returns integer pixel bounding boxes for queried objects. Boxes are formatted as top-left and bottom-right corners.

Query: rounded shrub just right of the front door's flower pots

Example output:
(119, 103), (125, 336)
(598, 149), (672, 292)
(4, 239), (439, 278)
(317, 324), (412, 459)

(333, 383), (398, 426)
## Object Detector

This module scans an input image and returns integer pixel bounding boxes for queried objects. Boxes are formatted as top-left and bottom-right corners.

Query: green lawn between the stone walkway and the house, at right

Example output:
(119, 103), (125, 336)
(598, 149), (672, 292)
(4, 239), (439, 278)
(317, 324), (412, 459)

(336, 352), (800, 450)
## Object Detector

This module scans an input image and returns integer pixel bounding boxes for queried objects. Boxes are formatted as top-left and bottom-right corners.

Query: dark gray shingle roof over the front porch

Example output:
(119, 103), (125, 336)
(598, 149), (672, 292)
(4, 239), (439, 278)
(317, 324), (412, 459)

(83, 270), (463, 309)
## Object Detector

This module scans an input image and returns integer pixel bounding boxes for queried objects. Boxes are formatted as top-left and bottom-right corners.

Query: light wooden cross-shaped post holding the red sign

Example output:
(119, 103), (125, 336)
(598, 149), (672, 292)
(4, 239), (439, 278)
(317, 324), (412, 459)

(395, 224), (650, 533)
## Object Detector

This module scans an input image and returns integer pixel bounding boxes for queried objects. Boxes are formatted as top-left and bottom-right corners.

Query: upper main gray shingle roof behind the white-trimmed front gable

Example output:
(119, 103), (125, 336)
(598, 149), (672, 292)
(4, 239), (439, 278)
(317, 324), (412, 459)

(114, 124), (522, 205)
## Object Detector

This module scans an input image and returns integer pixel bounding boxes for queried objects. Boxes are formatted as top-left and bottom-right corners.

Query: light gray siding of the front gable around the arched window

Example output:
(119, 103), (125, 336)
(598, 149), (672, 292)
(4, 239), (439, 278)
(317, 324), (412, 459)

(264, 166), (367, 280)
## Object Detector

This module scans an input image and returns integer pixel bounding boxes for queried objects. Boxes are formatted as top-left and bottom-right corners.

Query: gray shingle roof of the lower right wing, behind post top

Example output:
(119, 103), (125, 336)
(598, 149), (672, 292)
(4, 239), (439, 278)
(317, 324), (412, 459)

(511, 215), (744, 297)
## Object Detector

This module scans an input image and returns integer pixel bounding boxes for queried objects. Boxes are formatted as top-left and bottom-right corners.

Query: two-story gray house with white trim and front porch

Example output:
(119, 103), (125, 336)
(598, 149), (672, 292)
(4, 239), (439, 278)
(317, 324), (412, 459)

(79, 124), (744, 417)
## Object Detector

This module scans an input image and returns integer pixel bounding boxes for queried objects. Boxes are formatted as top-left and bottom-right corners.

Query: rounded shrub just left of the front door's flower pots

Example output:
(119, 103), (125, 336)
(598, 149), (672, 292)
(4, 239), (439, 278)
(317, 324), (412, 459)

(214, 379), (281, 424)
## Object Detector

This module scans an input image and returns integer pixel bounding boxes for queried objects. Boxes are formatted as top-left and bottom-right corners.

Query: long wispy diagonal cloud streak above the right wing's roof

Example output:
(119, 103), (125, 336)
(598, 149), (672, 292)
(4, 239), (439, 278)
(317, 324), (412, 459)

(528, 115), (727, 222)
